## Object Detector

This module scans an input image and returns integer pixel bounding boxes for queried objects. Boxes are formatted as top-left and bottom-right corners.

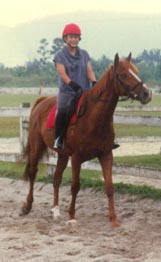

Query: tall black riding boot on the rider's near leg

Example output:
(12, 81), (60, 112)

(54, 111), (66, 149)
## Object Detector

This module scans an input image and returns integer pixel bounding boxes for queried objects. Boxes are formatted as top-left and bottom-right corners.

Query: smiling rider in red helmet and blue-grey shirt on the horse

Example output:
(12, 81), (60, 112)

(53, 24), (119, 149)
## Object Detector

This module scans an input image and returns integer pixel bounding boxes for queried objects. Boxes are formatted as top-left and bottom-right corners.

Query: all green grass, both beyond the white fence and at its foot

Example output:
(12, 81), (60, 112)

(0, 95), (161, 199)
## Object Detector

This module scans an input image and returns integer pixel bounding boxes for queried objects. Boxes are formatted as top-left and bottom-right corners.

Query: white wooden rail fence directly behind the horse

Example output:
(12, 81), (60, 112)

(0, 103), (161, 179)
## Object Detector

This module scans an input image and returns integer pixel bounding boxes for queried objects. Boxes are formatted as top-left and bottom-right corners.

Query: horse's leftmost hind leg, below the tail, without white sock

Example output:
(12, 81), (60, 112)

(21, 134), (45, 215)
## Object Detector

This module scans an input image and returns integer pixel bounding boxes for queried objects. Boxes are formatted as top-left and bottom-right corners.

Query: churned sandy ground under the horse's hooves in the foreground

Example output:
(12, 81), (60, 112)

(0, 178), (161, 262)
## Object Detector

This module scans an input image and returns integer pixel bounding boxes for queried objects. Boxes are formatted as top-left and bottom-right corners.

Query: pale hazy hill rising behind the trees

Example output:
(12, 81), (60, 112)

(0, 12), (161, 66)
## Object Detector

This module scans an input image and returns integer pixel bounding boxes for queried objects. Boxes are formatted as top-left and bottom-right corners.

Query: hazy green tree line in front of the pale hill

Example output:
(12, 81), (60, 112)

(0, 38), (161, 87)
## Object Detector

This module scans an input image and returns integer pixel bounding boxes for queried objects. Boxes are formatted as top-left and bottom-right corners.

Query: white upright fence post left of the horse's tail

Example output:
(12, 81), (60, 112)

(20, 103), (30, 153)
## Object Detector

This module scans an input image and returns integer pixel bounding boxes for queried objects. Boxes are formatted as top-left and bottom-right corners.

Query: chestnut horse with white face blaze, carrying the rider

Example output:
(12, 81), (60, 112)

(22, 53), (152, 226)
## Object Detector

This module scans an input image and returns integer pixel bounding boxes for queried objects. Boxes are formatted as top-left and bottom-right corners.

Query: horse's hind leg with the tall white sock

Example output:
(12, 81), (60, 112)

(52, 155), (69, 220)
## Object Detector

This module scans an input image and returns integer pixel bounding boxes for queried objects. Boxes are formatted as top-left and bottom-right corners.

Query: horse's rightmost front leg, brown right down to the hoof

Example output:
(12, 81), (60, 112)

(99, 152), (119, 227)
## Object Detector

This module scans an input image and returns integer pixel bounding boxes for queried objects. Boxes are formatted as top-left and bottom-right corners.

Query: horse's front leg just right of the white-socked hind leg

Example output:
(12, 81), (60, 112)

(69, 155), (81, 222)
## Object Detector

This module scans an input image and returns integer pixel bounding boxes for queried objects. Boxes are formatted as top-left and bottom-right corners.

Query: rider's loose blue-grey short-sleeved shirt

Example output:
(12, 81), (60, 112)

(53, 46), (90, 95)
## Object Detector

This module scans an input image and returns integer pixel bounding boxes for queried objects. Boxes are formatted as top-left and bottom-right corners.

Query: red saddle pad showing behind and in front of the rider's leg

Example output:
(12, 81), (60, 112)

(45, 96), (86, 129)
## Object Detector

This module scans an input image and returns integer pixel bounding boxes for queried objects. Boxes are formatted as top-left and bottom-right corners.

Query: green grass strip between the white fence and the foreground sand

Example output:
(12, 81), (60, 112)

(0, 162), (161, 200)
